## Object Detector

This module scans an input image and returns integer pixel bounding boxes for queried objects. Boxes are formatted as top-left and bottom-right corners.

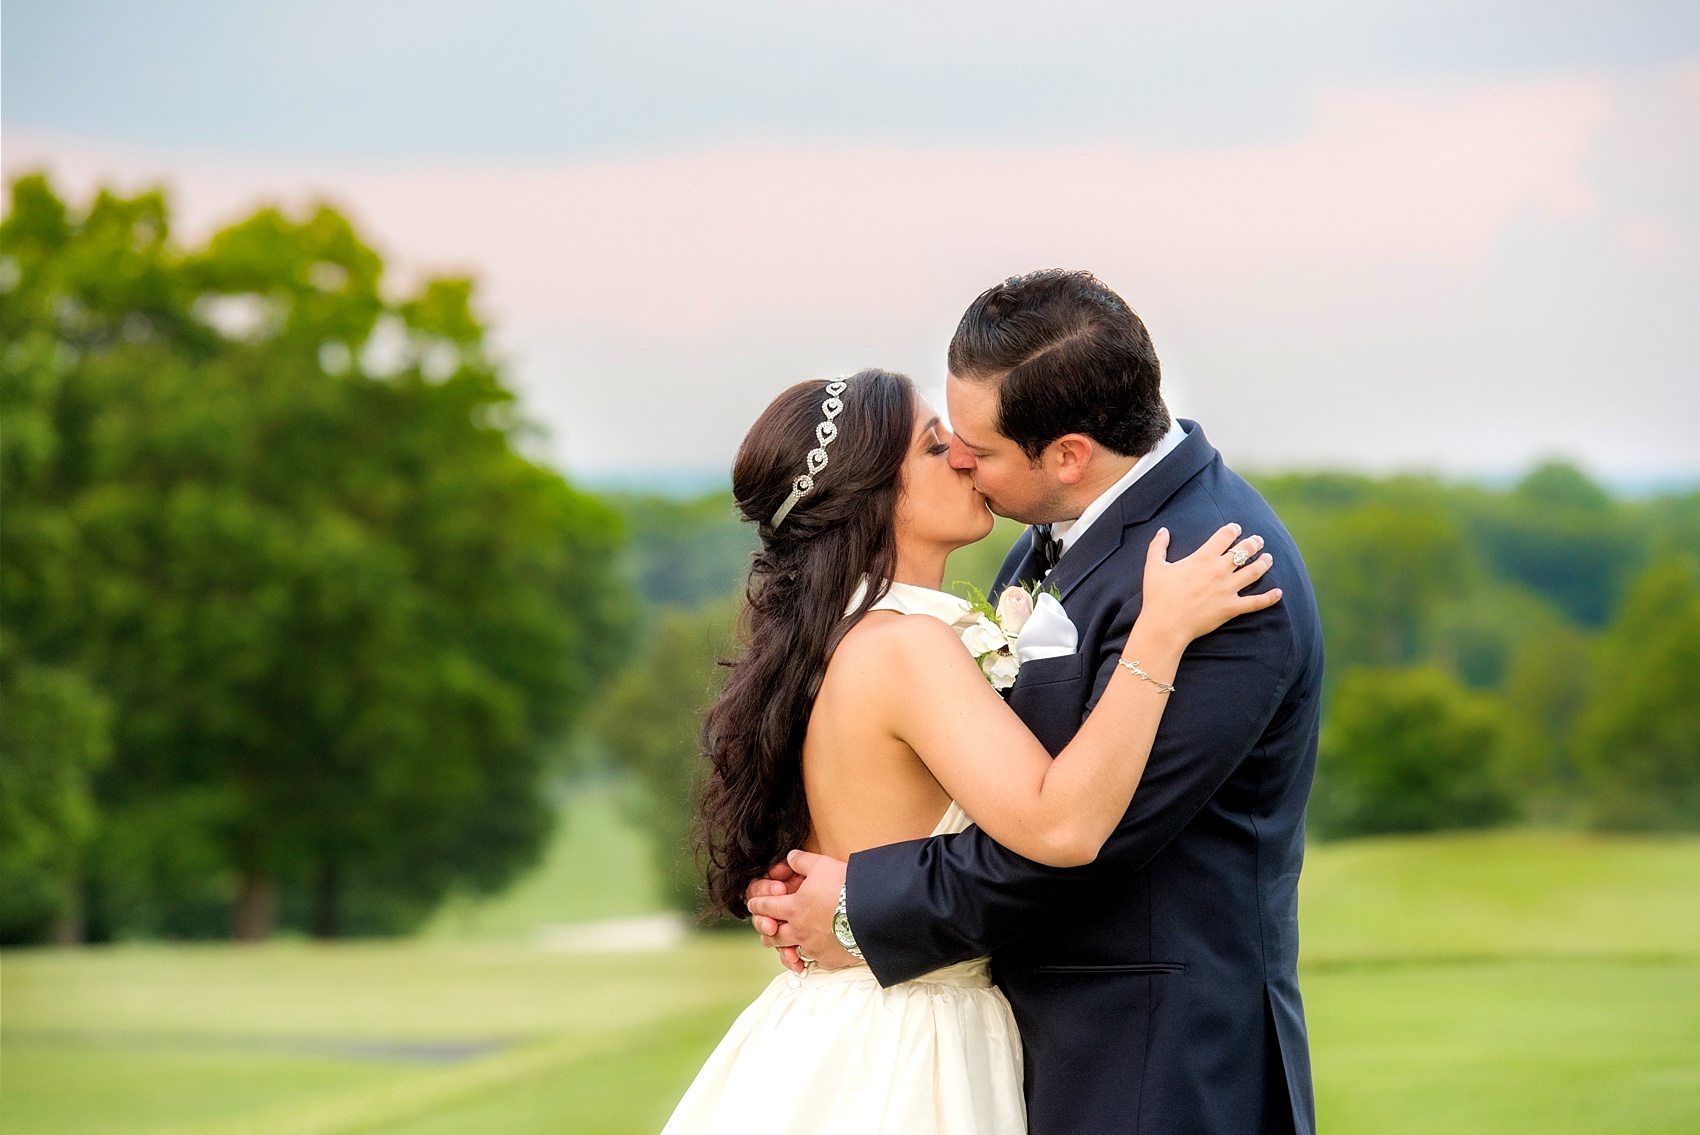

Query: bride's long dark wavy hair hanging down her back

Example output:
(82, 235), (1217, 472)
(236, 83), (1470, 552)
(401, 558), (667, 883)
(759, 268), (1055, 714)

(700, 370), (915, 918)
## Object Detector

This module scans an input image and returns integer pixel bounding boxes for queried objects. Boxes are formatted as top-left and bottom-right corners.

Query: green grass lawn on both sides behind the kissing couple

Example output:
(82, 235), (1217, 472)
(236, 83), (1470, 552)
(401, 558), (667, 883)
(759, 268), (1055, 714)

(0, 815), (1700, 1135)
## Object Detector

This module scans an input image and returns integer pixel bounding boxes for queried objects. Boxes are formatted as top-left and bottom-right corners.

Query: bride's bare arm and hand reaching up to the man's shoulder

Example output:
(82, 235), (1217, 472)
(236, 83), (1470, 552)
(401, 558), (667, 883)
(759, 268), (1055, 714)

(870, 525), (1280, 867)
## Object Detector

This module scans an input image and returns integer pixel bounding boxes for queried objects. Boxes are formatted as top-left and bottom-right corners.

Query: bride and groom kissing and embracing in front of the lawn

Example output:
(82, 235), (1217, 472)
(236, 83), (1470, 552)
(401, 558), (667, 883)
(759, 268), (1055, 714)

(665, 270), (1323, 1135)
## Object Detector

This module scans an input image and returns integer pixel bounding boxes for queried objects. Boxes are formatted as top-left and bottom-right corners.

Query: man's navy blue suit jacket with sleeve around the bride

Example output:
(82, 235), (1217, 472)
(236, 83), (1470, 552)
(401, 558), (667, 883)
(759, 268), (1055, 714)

(847, 421), (1323, 1135)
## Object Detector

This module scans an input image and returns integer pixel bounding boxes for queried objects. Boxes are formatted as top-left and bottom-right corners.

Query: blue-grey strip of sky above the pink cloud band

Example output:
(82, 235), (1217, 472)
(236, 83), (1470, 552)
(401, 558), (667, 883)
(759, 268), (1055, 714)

(13, 0), (1700, 158)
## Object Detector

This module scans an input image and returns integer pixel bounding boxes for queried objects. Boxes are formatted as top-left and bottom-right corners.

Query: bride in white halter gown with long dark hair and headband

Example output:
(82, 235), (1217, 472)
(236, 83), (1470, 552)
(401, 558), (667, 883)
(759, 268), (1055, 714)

(663, 370), (1280, 1135)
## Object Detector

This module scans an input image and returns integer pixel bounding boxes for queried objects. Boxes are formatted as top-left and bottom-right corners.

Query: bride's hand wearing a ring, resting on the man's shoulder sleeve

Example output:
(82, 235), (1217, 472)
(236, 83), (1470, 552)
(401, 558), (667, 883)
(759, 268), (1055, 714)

(1139, 523), (1280, 647)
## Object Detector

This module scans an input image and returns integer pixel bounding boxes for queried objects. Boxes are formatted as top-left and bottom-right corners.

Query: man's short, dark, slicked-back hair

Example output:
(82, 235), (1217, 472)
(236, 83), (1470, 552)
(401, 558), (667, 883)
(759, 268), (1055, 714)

(950, 268), (1170, 460)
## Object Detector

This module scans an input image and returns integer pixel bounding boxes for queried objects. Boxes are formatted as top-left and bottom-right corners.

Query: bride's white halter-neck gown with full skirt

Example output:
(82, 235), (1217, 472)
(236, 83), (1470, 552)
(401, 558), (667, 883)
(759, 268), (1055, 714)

(663, 583), (1027, 1135)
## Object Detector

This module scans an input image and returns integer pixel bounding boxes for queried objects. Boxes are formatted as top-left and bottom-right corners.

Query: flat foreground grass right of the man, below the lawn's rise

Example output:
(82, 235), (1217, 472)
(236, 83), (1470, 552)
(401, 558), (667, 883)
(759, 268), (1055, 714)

(1301, 958), (1700, 1135)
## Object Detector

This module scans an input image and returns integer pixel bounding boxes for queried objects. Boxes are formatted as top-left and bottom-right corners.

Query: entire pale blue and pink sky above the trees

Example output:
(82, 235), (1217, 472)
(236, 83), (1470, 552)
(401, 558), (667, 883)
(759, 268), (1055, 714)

(0, 0), (1700, 484)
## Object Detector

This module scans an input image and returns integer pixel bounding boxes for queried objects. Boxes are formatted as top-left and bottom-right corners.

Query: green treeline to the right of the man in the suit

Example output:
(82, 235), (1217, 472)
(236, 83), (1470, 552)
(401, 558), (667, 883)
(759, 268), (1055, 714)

(1260, 464), (1700, 836)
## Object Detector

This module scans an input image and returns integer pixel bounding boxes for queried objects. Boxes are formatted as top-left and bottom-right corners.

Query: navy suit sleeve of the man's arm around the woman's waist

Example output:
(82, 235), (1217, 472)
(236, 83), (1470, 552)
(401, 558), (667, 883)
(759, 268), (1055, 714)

(845, 603), (1297, 985)
